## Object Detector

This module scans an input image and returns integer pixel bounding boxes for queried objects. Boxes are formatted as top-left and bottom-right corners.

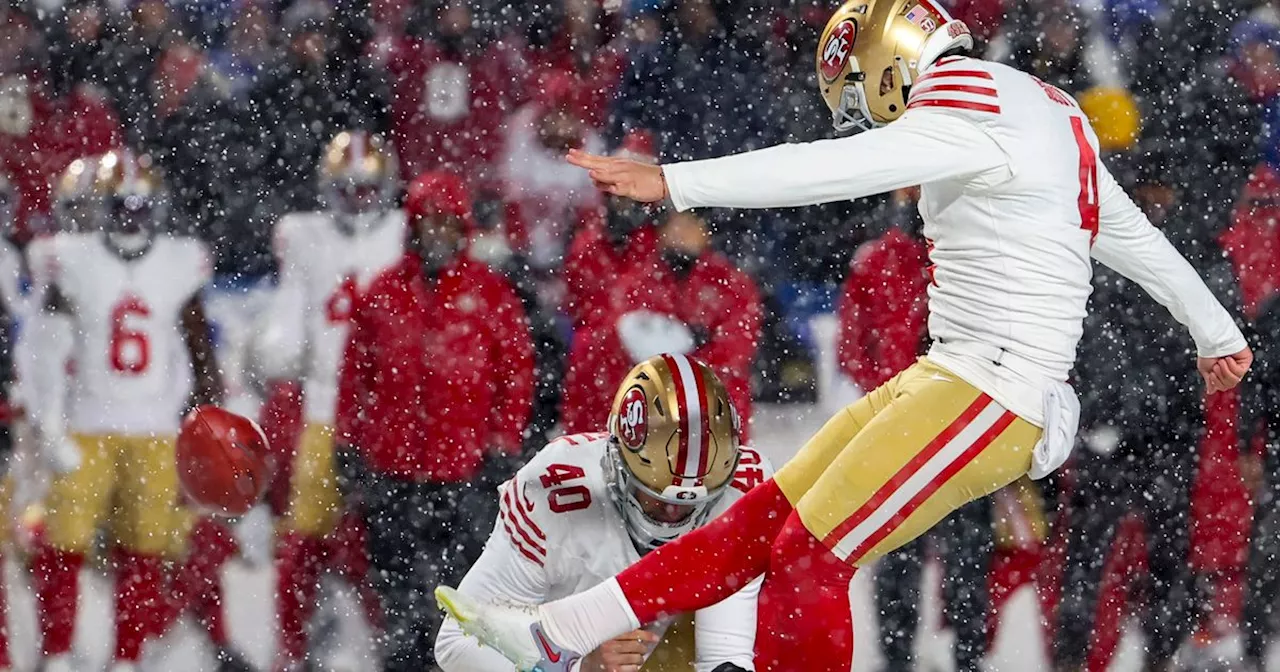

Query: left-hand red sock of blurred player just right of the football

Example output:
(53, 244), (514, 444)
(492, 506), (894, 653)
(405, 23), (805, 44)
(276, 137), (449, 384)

(275, 532), (324, 662)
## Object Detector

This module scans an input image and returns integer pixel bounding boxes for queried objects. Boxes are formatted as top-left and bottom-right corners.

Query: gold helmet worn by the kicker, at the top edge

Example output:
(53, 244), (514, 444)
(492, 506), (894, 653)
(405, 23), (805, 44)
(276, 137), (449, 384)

(818, 0), (973, 132)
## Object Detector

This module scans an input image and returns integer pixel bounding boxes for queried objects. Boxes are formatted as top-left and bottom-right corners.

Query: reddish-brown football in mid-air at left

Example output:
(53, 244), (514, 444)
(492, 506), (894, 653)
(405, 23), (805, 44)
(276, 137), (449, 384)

(178, 404), (274, 516)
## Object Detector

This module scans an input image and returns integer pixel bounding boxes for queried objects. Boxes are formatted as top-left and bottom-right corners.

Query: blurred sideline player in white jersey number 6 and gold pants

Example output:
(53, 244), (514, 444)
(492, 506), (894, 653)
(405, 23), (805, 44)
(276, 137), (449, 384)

(31, 150), (221, 672)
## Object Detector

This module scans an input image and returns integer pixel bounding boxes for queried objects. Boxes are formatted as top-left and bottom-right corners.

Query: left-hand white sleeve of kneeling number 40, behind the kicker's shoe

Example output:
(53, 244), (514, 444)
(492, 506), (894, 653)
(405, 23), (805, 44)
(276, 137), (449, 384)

(435, 518), (547, 672)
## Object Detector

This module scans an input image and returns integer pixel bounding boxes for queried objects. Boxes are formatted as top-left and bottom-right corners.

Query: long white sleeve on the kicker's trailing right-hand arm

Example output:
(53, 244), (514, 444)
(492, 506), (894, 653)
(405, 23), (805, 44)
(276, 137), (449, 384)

(1091, 166), (1245, 357)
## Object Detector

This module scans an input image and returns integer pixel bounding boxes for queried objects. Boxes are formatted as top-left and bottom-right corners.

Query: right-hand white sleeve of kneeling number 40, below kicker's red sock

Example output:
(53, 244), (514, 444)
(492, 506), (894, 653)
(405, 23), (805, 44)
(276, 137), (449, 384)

(694, 577), (763, 672)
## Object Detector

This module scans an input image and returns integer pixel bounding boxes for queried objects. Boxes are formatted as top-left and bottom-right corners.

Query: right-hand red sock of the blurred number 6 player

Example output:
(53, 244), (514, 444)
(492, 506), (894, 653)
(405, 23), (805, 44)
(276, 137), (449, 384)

(114, 549), (165, 660)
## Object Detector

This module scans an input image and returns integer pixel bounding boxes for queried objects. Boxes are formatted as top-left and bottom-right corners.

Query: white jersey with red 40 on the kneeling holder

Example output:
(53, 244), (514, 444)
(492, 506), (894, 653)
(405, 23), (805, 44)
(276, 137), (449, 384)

(435, 433), (773, 672)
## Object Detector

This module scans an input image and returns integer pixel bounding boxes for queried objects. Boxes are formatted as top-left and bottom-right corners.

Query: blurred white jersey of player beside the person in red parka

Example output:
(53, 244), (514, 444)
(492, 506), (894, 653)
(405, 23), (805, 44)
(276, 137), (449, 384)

(262, 210), (404, 425)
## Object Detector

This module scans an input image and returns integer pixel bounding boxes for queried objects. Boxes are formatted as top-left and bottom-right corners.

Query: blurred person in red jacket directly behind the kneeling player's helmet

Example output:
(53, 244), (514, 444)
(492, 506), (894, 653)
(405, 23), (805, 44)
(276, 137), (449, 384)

(609, 212), (762, 443)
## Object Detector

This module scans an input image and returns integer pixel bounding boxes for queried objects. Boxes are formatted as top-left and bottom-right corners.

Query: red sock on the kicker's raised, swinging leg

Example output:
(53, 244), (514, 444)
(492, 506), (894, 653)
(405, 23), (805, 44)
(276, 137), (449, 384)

(618, 479), (791, 623)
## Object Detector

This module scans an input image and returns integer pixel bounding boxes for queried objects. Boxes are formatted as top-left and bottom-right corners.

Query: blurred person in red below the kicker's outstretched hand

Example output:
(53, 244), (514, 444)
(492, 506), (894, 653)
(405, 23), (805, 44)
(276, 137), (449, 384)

(561, 133), (659, 434)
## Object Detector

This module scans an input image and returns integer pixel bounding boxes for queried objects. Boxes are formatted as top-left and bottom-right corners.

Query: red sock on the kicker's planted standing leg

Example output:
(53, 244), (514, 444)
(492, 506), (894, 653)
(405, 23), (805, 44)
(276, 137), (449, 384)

(755, 513), (855, 672)
